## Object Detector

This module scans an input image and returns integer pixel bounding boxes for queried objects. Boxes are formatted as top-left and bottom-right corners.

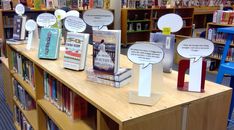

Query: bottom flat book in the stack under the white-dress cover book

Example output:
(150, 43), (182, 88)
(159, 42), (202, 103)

(87, 75), (131, 88)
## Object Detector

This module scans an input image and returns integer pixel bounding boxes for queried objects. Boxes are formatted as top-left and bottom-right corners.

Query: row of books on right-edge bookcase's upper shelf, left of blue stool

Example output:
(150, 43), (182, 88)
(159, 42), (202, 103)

(207, 28), (227, 43)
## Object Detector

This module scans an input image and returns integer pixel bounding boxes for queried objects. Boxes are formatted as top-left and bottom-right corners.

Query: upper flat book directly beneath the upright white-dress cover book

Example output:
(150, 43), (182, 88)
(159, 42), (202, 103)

(86, 68), (132, 82)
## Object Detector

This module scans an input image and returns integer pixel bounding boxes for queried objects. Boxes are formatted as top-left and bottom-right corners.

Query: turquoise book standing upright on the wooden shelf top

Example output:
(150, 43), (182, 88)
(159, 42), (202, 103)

(38, 28), (61, 59)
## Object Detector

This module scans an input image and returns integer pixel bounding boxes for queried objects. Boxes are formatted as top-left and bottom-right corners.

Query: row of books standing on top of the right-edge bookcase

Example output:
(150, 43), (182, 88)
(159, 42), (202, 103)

(213, 10), (234, 24)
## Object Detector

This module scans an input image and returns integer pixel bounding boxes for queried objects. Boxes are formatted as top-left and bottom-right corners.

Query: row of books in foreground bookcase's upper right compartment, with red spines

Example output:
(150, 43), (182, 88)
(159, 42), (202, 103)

(44, 72), (88, 120)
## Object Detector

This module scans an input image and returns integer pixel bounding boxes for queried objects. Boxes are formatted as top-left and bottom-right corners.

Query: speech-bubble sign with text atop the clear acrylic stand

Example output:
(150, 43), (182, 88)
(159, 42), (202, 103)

(127, 43), (164, 68)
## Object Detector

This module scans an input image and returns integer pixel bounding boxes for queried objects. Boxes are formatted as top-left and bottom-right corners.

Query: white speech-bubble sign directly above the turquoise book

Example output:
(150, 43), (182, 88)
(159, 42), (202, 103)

(37, 13), (56, 27)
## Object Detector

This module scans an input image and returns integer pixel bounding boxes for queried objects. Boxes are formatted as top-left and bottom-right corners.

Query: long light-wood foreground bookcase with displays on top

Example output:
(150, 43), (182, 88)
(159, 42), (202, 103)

(7, 44), (231, 130)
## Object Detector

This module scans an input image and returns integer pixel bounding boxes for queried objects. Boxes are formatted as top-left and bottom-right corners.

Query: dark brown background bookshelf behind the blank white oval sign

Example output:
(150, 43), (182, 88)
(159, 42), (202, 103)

(121, 8), (194, 46)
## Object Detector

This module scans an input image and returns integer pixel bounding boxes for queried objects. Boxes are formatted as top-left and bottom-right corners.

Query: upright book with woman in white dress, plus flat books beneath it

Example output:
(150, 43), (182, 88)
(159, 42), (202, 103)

(86, 30), (131, 87)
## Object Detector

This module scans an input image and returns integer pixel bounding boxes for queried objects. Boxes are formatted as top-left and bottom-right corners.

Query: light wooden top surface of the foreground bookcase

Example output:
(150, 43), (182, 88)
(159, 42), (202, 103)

(10, 44), (231, 125)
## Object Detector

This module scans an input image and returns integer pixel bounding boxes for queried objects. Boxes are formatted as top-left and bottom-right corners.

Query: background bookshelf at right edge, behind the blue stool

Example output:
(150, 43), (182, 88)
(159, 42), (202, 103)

(206, 22), (234, 73)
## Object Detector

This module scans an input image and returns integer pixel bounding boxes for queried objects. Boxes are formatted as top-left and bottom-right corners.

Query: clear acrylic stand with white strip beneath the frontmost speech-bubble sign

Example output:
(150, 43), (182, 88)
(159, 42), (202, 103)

(128, 63), (163, 106)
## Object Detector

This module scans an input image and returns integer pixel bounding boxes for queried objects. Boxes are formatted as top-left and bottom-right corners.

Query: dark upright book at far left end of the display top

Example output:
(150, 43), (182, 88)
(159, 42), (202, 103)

(13, 15), (27, 40)
